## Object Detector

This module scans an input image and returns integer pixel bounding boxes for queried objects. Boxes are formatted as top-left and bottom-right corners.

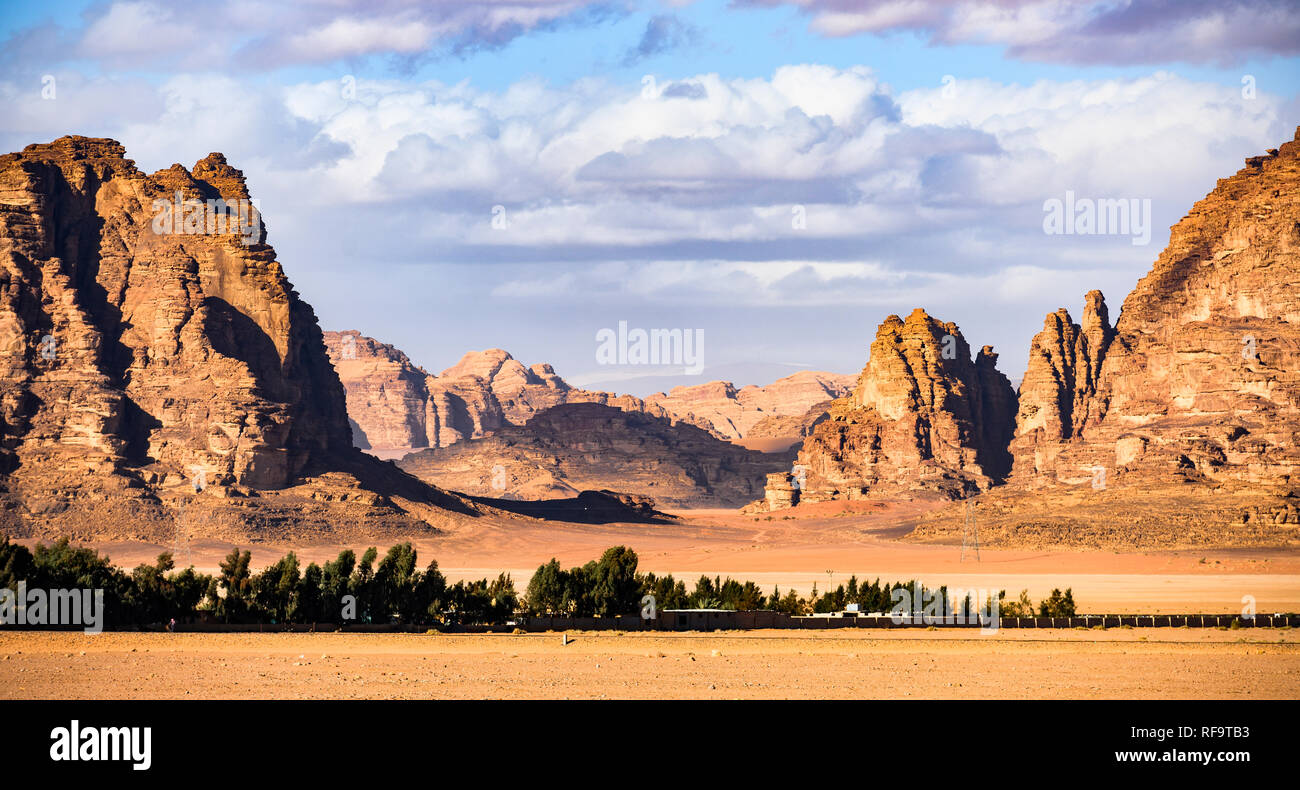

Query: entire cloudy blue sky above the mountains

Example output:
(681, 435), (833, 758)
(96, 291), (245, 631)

(0, 0), (1300, 396)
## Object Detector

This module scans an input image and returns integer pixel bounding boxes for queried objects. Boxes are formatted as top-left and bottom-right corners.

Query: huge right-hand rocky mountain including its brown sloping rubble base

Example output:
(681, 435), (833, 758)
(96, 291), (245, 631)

(915, 130), (1300, 548)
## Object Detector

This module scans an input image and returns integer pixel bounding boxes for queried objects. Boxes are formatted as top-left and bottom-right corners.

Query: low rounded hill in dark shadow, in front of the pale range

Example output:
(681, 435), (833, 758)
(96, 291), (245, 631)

(399, 403), (793, 507)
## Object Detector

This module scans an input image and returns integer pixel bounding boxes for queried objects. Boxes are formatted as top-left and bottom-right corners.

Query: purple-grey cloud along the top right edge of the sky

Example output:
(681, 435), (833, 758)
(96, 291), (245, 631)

(736, 0), (1300, 64)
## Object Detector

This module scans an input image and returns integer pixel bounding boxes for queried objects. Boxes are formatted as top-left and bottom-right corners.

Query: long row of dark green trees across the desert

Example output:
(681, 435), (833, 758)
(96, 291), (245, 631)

(0, 538), (1075, 626)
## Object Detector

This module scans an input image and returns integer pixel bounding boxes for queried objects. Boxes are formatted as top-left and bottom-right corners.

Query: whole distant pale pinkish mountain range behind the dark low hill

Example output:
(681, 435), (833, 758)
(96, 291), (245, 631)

(325, 330), (852, 459)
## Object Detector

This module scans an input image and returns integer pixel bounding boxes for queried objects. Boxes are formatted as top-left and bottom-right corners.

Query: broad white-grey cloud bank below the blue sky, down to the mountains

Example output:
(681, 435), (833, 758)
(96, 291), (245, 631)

(0, 58), (1295, 384)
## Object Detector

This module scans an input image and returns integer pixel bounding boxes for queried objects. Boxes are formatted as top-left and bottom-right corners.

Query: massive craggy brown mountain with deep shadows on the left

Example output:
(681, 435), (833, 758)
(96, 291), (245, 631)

(0, 136), (483, 538)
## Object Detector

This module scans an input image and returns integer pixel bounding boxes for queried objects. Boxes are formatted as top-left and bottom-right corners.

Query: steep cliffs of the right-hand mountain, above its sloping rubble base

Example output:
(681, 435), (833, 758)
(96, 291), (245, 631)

(1013, 132), (1300, 492)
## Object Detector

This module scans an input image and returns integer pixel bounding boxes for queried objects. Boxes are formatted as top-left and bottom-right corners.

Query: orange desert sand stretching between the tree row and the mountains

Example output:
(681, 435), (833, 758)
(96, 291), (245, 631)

(43, 502), (1300, 615)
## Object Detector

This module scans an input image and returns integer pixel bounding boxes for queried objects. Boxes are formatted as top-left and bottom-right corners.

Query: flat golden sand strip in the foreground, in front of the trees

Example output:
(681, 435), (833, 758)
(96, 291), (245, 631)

(0, 629), (1300, 699)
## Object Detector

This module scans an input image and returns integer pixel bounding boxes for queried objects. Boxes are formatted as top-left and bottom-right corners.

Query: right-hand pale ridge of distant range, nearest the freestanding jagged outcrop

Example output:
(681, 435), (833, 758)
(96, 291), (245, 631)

(646, 370), (854, 439)
